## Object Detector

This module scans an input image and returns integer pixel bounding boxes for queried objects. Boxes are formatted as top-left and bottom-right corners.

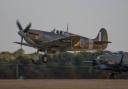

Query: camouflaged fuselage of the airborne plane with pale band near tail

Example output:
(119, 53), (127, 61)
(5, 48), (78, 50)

(21, 29), (107, 51)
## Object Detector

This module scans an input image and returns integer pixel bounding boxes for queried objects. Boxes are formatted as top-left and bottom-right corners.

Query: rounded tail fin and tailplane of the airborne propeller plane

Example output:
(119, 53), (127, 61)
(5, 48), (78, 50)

(94, 28), (111, 49)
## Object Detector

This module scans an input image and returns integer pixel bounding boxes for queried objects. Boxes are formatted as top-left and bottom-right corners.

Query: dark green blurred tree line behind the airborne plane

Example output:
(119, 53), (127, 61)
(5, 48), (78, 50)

(0, 49), (127, 79)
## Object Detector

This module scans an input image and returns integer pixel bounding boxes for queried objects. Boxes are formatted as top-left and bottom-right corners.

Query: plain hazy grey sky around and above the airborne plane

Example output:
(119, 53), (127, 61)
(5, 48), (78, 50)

(0, 0), (128, 52)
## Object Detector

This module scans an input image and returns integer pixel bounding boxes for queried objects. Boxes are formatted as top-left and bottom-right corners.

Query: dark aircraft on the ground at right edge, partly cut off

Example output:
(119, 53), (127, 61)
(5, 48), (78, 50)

(92, 52), (128, 78)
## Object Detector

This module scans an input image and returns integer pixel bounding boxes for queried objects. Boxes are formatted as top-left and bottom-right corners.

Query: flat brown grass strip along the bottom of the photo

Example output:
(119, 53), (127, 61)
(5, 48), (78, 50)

(0, 79), (128, 89)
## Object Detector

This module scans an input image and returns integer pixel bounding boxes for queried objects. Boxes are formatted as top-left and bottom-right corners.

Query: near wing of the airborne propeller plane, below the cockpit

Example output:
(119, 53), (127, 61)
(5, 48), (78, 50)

(43, 35), (80, 49)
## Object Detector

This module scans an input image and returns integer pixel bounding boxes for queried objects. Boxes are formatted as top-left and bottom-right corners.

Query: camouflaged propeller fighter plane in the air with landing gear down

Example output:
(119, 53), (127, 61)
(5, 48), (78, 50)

(14, 20), (111, 63)
